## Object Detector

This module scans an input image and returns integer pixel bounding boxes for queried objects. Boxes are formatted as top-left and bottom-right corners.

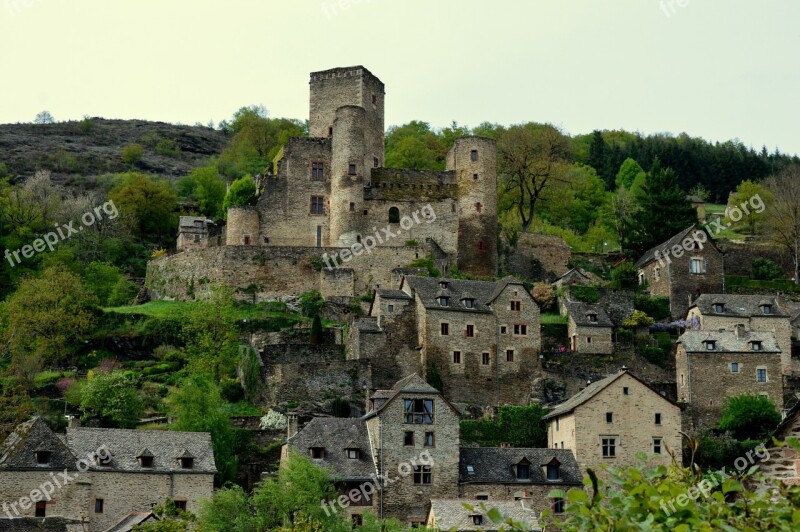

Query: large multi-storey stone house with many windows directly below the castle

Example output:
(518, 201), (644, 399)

(348, 276), (541, 407)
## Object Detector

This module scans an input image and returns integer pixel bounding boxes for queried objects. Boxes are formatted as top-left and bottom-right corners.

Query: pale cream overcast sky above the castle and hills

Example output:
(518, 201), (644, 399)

(0, 0), (800, 153)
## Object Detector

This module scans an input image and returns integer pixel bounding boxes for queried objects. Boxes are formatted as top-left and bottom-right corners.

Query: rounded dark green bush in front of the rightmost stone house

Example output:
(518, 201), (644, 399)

(719, 395), (781, 440)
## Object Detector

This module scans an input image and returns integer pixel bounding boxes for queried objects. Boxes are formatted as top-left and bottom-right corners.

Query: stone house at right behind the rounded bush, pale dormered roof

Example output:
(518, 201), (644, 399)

(675, 326), (783, 427)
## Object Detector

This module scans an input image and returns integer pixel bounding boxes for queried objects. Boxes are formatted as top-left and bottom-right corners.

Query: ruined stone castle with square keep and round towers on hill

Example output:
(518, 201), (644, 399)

(148, 66), (497, 298)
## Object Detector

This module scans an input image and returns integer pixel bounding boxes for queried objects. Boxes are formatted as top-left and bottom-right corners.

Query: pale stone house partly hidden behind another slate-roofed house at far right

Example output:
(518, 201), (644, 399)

(686, 294), (792, 377)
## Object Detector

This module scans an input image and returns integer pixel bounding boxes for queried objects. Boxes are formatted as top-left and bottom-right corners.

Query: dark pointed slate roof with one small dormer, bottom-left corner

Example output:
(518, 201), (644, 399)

(0, 417), (78, 471)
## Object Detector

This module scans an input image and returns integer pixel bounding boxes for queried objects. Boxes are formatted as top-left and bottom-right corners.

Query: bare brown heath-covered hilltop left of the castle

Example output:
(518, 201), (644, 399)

(0, 118), (228, 188)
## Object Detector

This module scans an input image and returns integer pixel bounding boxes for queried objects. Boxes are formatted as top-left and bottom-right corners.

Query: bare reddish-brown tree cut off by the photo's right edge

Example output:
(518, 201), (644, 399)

(764, 165), (800, 284)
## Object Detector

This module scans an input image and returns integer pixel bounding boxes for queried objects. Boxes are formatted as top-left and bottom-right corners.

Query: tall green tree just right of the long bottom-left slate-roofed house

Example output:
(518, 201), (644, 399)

(166, 375), (238, 486)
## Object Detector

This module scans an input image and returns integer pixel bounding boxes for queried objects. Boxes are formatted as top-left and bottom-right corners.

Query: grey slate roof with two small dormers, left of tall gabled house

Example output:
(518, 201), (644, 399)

(286, 417), (376, 481)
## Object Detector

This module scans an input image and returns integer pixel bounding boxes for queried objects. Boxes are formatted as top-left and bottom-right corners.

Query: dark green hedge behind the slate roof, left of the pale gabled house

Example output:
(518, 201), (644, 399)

(461, 404), (548, 447)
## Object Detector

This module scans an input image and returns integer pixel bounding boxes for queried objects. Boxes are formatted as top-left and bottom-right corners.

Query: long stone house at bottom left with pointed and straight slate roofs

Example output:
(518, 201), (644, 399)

(0, 418), (216, 532)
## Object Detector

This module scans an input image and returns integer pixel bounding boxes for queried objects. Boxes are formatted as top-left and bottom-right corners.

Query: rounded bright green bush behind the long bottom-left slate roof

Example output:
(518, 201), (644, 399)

(81, 371), (144, 429)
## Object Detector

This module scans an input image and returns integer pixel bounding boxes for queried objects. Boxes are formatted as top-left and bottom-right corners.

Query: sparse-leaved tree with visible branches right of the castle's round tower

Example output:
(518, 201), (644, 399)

(498, 123), (569, 232)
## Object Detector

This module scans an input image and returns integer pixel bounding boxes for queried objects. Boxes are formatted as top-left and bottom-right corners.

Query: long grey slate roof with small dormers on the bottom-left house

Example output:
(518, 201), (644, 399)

(67, 427), (217, 474)
